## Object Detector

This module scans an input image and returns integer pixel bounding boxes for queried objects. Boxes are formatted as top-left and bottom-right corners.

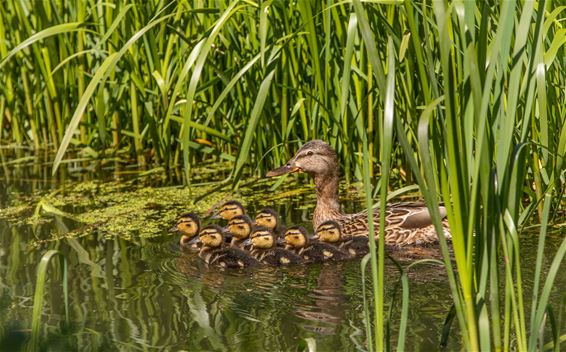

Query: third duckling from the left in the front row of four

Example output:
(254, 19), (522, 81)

(285, 226), (353, 262)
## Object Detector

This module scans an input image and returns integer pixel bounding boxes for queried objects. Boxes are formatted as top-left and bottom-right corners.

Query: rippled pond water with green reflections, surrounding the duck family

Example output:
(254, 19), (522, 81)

(0, 155), (566, 351)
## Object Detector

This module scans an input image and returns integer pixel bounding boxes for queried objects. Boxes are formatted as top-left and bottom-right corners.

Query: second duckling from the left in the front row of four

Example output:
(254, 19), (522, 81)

(248, 227), (304, 266)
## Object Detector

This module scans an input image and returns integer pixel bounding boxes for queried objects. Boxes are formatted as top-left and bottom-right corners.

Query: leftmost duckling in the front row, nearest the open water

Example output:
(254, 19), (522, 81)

(198, 225), (261, 268)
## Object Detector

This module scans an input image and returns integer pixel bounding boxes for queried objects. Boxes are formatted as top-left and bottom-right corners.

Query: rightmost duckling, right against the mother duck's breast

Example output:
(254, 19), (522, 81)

(315, 220), (369, 257)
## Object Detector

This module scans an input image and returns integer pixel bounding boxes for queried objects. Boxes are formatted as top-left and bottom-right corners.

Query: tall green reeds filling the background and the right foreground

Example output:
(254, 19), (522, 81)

(0, 0), (566, 350)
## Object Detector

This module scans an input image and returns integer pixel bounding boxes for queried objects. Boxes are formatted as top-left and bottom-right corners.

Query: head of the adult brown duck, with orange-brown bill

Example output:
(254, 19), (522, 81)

(267, 140), (338, 177)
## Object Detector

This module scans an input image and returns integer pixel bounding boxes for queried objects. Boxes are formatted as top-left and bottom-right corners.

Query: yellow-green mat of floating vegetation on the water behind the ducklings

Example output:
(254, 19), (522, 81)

(0, 168), (359, 245)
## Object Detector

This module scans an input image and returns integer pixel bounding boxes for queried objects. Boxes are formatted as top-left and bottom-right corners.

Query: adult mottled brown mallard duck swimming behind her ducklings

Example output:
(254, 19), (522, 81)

(267, 140), (450, 246)
